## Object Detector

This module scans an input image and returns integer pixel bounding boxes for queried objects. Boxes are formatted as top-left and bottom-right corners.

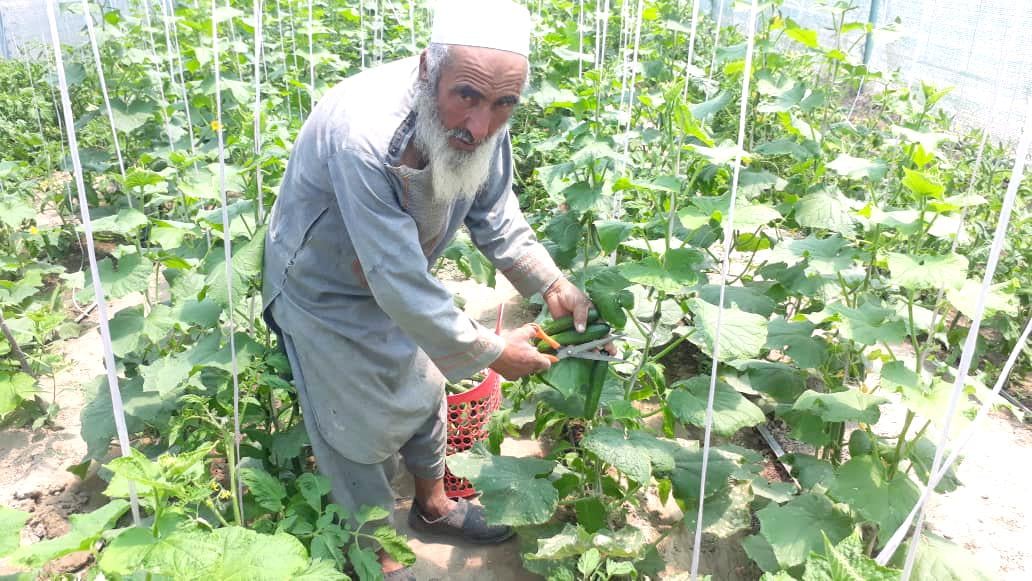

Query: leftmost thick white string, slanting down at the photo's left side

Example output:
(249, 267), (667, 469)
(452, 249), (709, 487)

(46, 0), (139, 525)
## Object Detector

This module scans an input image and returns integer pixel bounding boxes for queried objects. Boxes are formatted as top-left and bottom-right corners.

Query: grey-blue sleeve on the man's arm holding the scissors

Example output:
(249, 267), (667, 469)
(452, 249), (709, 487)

(329, 150), (505, 381)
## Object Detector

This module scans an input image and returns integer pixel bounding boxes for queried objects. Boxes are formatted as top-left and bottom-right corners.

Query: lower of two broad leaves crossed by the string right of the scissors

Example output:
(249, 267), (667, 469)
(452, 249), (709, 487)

(667, 376), (766, 435)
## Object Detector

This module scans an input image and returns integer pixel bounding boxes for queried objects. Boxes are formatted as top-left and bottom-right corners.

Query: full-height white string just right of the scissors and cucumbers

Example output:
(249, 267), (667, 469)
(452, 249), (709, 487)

(691, 0), (756, 581)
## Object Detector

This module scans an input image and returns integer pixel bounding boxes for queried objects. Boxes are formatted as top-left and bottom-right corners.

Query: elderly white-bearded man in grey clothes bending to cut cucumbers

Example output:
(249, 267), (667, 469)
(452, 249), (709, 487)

(263, 0), (589, 579)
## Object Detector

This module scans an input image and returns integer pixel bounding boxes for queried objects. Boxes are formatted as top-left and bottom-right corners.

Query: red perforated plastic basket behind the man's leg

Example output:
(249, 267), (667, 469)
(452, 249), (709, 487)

(445, 304), (505, 498)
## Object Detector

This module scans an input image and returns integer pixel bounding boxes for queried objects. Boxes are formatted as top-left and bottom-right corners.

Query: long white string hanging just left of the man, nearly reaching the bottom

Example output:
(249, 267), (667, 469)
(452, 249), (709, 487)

(212, 0), (244, 514)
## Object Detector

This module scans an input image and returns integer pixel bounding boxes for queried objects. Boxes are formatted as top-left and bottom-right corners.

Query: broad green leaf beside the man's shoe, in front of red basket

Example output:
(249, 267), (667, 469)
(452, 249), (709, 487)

(448, 446), (558, 526)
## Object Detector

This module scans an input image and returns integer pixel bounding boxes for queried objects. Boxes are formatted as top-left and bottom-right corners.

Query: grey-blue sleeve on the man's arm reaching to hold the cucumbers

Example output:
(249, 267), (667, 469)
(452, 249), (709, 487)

(465, 136), (561, 297)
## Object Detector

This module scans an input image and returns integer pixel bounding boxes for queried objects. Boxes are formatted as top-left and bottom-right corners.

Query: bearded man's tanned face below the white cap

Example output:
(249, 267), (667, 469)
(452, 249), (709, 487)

(437, 45), (527, 152)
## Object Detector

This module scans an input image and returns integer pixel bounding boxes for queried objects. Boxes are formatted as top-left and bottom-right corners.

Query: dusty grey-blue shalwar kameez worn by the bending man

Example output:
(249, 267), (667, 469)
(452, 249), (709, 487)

(262, 57), (560, 524)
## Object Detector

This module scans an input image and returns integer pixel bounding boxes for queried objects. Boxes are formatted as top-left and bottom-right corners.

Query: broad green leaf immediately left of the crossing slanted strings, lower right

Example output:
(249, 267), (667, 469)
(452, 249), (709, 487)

(828, 456), (921, 545)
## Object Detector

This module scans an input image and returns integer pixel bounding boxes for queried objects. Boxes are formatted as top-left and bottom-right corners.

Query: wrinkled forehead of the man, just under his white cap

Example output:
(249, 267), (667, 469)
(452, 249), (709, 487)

(442, 44), (528, 97)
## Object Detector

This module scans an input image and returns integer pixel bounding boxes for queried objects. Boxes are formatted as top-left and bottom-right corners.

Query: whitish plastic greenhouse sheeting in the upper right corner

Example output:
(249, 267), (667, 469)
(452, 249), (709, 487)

(704, 0), (1032, 141)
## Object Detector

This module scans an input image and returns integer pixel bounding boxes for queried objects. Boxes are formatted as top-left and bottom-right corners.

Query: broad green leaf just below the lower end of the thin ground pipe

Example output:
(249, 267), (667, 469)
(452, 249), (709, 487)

(756, 492), (852, 569)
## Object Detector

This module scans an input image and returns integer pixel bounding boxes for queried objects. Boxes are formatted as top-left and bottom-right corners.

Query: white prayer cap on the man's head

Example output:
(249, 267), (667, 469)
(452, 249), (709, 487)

(430, 0), (530, 58)
